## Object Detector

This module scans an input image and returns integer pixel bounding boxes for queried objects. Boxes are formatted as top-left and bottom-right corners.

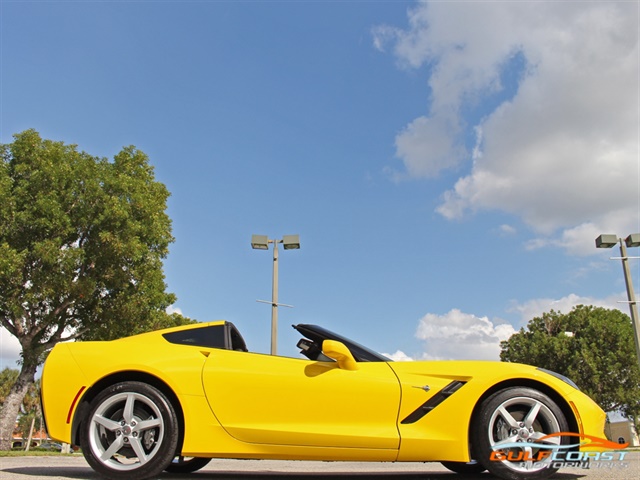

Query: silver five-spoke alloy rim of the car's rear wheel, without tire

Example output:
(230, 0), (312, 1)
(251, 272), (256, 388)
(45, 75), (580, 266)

(88, 391), (165, 471)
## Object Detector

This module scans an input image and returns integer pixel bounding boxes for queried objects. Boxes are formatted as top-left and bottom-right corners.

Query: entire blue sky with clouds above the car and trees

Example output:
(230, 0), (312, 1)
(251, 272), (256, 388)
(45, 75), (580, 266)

(0, 0), (640, 367)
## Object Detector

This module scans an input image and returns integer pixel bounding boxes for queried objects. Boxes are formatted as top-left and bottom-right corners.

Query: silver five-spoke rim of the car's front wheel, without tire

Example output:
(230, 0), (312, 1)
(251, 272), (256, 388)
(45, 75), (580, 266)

(487, 397), (563, 473)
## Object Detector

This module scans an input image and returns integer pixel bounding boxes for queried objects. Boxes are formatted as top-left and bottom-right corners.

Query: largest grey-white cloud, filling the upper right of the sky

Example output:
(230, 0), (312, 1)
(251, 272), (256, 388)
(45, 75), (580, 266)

(374, 1), (640, 253)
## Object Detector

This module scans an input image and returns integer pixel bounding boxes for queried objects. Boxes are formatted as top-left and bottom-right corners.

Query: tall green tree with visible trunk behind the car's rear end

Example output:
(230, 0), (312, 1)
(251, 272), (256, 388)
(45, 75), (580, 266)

(0, 130), (192, 450)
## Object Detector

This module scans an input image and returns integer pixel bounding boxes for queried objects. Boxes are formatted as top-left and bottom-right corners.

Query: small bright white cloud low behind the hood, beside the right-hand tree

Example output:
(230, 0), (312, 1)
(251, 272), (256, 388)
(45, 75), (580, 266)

(416, 309), (515, 360)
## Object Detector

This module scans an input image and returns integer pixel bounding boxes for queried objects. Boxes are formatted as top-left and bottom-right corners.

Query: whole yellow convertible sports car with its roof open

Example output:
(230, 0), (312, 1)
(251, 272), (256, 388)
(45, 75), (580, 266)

(42, 321), (605, 480)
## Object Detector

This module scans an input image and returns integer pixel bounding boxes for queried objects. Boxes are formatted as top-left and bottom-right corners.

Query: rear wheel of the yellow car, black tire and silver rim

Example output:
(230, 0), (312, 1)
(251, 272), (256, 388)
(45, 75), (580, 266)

(80, 382), (178, 480)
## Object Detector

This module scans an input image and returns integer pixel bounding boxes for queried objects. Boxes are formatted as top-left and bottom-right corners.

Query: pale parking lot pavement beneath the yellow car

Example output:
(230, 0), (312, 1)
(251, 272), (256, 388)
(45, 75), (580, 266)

(0, 452), (640, 480)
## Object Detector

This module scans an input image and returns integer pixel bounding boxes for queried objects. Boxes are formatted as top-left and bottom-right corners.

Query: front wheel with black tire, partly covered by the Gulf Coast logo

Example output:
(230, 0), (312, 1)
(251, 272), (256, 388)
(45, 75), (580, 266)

(471, 387), (569, 480)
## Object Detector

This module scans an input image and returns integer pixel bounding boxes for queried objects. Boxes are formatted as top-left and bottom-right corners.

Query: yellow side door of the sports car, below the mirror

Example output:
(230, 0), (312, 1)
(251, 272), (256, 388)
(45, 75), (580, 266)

(202, 350), (400, 449)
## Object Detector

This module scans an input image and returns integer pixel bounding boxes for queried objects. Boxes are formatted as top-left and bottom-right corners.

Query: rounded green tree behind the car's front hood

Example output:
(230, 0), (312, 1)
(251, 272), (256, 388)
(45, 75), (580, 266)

(500, 305), (640, 434)
